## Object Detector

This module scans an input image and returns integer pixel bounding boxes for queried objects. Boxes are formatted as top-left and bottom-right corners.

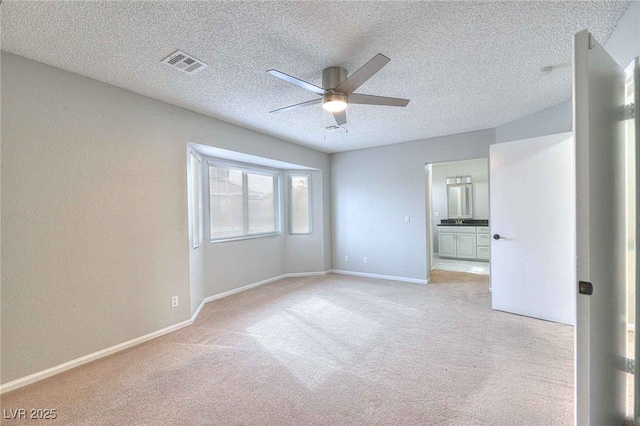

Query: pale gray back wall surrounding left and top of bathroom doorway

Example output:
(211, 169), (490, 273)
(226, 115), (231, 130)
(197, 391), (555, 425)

(331, 129), (495, 279)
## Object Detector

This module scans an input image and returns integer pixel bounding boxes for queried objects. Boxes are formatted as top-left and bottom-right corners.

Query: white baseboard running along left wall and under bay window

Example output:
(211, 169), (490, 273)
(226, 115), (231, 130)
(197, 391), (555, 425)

(0, 271), (331, 394)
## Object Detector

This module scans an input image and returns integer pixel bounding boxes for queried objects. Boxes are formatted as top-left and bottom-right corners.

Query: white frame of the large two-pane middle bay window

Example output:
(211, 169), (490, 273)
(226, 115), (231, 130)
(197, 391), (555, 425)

(207, 158), (282, 244)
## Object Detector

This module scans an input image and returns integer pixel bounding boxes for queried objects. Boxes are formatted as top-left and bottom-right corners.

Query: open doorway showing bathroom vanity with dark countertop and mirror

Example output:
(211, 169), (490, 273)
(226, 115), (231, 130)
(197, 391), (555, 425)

(426, 158), (490, 275)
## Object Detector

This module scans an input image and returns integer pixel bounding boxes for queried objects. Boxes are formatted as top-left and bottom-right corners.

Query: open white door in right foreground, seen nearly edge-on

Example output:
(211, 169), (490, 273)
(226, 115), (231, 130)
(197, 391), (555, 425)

(573, 31), (626, 425)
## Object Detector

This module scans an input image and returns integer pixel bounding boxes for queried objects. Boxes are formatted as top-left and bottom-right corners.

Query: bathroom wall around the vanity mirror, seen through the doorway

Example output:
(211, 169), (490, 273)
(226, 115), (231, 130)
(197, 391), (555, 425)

(431, 158), (489, 252)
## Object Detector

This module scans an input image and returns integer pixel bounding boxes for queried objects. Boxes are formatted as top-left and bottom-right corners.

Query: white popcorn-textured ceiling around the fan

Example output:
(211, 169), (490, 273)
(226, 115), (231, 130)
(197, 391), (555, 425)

(1, 0), (629, 152)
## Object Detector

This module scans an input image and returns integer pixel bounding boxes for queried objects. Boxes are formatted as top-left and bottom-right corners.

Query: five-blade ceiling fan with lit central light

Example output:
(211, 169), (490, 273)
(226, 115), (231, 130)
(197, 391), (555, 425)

(267, 53), (409, 129)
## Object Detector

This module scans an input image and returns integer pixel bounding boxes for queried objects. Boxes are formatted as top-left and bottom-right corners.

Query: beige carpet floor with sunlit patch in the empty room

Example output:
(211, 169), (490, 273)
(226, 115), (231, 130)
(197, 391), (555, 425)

(1, 271), (573, 426)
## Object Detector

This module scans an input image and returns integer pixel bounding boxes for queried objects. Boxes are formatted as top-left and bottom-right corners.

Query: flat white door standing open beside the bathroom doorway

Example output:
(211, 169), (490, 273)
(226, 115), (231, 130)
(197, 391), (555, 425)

(489, 133), (576, 324)
